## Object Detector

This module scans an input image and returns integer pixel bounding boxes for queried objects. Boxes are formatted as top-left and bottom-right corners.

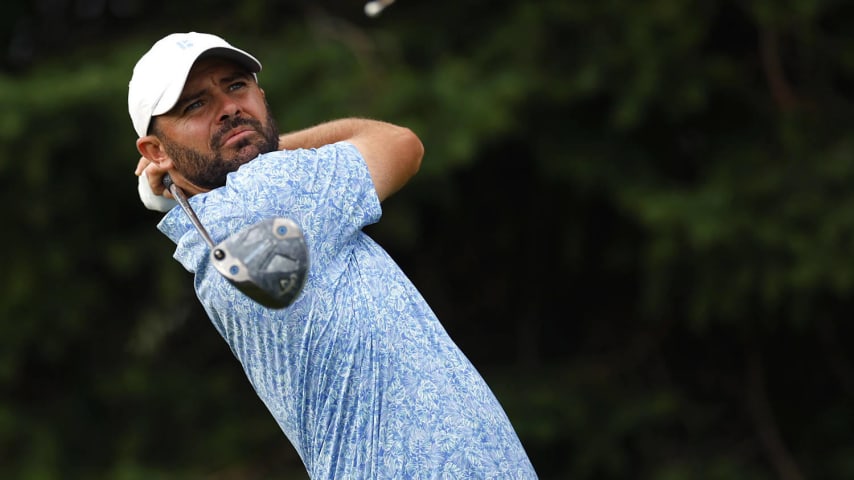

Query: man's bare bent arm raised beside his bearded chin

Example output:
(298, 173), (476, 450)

(279, 118), (424, 201)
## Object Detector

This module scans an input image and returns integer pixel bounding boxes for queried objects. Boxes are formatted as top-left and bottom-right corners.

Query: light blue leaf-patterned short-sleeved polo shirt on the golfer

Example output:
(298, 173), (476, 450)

(158, 143), (536, 479)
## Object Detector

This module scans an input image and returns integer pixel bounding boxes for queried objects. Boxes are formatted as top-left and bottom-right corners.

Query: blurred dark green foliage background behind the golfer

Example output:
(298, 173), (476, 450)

(0, 0), (854, 480)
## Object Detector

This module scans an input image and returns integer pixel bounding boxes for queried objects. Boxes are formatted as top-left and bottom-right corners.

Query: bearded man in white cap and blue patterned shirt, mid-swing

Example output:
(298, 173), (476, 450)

(128, 33), (536, 479)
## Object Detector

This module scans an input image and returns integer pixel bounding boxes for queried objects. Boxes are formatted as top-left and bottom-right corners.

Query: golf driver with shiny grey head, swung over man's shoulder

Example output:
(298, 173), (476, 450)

(163, 175), (308, 308)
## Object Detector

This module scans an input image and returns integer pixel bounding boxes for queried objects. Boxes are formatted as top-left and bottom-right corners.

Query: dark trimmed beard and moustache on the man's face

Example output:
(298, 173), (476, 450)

(156, 107), (279, 190)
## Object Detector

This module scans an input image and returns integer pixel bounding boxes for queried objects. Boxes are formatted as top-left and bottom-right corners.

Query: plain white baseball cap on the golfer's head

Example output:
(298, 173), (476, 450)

(128, 32), (261, 137)
